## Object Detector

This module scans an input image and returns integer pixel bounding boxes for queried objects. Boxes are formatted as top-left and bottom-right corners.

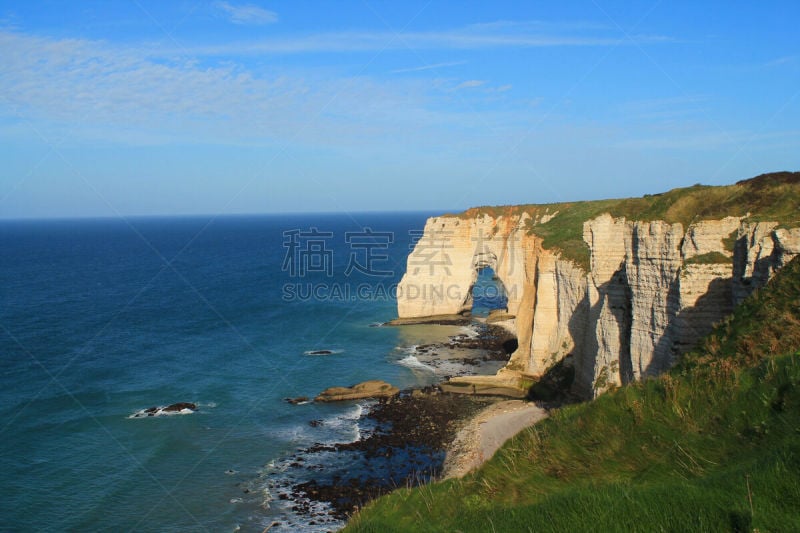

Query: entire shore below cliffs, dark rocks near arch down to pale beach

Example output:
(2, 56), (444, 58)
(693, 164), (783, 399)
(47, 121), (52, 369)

(270, 320), (548, 531)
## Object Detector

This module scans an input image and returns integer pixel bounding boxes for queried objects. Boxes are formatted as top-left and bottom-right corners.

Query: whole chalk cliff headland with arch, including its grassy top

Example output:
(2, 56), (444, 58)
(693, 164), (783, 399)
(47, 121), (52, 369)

(397, 172), (800, 397)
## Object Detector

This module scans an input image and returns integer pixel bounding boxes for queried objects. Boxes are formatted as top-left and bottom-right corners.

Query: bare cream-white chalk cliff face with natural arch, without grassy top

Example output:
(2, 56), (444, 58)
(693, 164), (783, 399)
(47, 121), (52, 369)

(398, 212), (800, 397)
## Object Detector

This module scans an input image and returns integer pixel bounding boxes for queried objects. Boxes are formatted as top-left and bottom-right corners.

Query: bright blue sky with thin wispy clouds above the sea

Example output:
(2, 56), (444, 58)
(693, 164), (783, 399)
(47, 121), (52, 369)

(0, 0), (800, 218)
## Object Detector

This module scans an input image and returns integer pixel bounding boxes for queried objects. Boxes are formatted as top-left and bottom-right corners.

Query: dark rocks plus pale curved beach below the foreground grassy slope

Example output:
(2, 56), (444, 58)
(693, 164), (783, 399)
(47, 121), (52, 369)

(286, 386), (548, 530)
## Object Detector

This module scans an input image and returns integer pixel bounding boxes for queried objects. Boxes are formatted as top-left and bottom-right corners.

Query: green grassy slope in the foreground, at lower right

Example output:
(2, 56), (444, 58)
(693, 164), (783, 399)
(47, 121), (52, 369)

(346, 260), (800, 533)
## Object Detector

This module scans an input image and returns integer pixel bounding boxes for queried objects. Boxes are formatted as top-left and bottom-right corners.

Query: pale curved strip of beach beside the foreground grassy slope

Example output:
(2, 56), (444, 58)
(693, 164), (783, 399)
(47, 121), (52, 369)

(443, 400), (547, 479)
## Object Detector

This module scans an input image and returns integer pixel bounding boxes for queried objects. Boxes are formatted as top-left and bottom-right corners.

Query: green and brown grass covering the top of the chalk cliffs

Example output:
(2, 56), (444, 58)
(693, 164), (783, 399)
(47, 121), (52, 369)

(459, 172), (800, 269)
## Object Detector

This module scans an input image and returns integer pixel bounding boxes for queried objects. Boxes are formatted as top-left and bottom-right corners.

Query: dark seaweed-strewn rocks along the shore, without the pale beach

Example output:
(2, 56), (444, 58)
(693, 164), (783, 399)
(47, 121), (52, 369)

(277, 322), (516, 525)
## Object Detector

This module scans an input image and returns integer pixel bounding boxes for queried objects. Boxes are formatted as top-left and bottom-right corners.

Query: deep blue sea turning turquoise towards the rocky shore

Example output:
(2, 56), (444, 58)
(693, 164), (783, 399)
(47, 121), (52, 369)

(0, 213), (506, 532)
